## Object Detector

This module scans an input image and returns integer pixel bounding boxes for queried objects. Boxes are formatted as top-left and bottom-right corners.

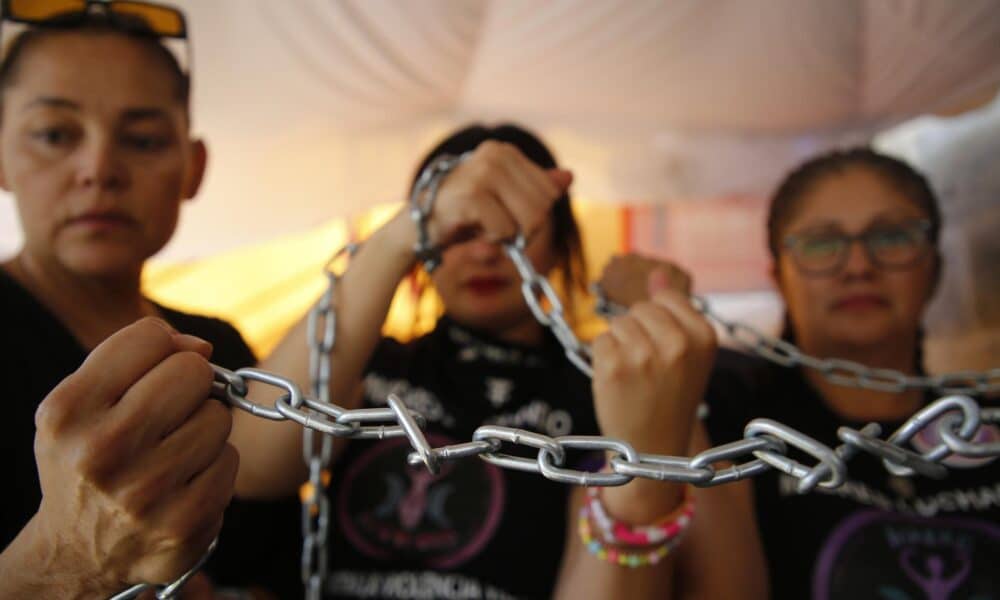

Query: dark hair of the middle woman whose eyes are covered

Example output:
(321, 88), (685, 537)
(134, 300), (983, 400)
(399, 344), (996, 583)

(410, 123), (587, 324)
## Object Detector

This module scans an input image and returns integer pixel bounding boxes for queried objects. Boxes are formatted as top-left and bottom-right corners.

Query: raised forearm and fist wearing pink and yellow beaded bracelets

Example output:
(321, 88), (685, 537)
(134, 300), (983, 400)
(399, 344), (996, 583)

(558, 273), (715, 598)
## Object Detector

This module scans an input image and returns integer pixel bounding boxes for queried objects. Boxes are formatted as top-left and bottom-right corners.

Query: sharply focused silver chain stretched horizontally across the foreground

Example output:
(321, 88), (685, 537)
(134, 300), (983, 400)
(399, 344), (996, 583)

(207, 366), (1000, 493)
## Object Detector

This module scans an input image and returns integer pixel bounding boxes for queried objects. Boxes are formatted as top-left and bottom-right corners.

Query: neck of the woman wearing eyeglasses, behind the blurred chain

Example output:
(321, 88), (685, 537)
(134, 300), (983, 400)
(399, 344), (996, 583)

(802, 332), (923, 421)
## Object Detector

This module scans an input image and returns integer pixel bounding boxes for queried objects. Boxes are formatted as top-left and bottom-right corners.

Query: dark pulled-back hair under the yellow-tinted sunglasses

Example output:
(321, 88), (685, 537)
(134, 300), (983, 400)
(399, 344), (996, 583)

(0, 14), (191, 113)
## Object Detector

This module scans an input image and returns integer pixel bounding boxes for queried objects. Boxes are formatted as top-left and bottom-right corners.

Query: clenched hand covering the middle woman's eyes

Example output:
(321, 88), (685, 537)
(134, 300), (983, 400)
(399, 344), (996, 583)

(429, 140), (573, 249)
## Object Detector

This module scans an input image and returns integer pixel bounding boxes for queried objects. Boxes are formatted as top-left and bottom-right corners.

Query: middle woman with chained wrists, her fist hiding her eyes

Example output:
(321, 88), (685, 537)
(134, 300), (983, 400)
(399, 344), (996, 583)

(232, 125), (754, 598)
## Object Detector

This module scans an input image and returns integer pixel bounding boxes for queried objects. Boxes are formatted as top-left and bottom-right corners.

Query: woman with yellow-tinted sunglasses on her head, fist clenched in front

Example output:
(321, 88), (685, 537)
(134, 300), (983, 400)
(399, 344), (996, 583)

(0, 0), (297, 598)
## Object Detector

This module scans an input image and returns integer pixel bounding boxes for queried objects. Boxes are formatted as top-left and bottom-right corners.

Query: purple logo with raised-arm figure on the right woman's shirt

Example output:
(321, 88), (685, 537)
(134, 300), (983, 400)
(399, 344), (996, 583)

(812, 510), (1000, 600)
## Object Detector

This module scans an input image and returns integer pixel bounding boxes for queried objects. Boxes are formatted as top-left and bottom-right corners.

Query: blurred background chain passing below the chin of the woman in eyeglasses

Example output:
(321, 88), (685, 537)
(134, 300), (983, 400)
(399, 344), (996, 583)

(592, 286), (1000, 395)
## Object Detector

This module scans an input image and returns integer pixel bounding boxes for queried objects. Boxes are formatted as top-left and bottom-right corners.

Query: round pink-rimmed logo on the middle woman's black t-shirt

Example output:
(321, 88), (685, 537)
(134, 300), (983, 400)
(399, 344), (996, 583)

(337, 434), (505, 569)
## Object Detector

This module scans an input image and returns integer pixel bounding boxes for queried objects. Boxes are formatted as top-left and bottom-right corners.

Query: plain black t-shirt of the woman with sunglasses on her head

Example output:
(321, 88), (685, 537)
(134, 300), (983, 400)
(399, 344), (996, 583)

(0, 271), (302, 597)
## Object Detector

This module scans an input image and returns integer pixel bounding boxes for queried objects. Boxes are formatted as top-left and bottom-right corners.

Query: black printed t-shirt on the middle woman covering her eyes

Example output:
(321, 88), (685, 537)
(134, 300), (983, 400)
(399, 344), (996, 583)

(325, 318), (597, 599)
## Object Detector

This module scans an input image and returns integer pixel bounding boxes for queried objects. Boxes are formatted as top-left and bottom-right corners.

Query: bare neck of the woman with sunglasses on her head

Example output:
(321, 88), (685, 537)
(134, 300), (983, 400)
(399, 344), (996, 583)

(2, 252), (158, 351)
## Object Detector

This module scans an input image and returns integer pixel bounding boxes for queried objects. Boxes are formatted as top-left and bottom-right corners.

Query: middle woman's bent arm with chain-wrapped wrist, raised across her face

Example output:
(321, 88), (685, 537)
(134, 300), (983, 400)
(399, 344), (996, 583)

(231, 142), (572, 497)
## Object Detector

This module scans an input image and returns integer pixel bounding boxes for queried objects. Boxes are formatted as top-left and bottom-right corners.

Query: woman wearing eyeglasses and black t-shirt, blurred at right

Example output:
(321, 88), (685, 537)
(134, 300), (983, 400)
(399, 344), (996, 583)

(707, 149), (1000, 600)
